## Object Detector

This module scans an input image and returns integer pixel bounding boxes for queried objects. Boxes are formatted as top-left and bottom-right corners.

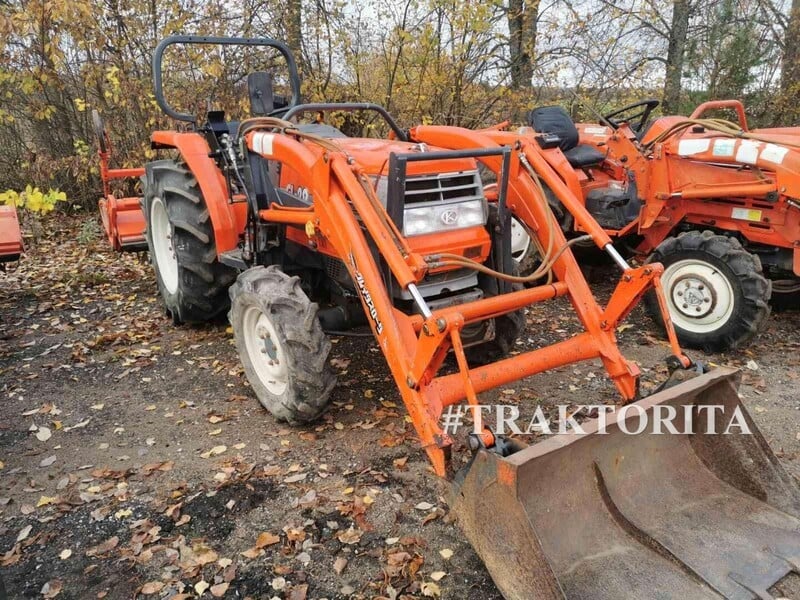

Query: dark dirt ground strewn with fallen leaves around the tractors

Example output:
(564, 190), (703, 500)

(0, 219), (800, 600)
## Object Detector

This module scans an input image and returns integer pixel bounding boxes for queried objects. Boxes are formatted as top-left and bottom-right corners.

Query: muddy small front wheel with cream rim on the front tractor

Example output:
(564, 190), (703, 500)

(228, 266), (336, 423)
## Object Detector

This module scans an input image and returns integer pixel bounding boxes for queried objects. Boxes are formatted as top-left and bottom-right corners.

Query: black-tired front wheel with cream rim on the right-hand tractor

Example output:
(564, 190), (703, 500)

(645, 231), (771, 352)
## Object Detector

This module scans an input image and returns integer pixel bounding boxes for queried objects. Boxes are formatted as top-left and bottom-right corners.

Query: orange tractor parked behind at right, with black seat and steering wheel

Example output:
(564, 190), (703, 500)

(527, 100), (800, 350)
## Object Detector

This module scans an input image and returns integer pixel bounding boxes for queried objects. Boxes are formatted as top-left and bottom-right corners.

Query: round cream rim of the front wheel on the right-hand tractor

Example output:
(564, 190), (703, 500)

(661, 259), (735, 333)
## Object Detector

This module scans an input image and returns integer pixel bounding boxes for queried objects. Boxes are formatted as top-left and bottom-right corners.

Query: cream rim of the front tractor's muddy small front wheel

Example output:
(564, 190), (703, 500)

(242, 306), (289, 396)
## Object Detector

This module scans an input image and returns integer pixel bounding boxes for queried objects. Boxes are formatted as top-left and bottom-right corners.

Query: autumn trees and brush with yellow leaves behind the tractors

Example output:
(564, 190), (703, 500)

(0, 0), (800, 206)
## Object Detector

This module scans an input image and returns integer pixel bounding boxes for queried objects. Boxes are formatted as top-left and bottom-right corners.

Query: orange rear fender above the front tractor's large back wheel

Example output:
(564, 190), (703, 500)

(150, 131), (247, 256)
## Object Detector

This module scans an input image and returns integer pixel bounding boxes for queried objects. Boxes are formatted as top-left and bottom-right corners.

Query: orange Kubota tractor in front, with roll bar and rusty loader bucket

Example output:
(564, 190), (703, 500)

(95, 36), (800, 599)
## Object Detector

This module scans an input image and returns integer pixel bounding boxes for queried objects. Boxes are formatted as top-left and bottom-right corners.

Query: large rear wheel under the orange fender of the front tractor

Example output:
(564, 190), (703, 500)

(142, 160), (236, 323)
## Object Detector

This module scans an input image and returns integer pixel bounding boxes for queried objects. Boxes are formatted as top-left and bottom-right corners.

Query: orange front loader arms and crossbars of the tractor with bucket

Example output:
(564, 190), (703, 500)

(244, 127), (689, 476)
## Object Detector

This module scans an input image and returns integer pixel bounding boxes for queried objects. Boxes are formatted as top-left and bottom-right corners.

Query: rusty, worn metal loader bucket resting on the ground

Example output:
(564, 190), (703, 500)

(451, 368), (800, 600)
